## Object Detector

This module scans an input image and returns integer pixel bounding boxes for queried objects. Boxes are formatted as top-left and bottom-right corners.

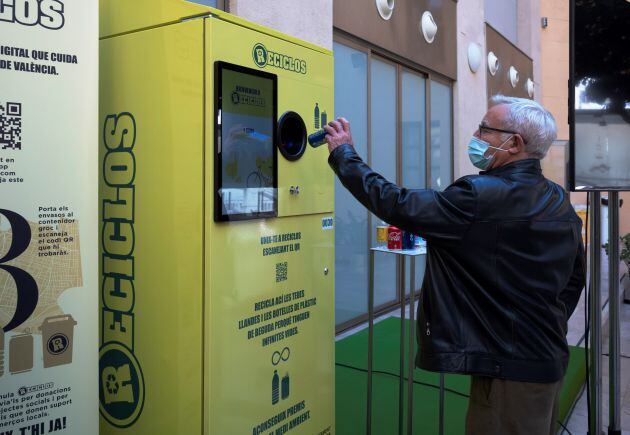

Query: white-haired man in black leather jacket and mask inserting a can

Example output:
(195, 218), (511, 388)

(325, 95), (585, 435)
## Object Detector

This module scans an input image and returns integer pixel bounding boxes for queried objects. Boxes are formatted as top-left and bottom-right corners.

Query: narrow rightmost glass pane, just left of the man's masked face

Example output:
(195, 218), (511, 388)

(431, 82), (453, 190)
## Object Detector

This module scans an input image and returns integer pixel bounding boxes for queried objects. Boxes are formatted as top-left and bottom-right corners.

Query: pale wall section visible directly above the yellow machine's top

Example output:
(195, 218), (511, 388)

(229, 0), (336, 50)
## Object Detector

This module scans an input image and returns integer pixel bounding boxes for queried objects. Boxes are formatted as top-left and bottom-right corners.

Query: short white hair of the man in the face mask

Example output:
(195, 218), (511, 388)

(490, 95), (557, 159)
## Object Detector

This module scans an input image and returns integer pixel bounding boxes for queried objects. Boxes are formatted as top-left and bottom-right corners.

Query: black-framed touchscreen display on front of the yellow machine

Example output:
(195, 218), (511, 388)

(216, 64), (277, 220)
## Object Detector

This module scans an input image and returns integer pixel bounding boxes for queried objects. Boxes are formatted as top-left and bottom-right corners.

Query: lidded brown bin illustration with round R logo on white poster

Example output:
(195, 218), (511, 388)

(39, 314), (77, 368)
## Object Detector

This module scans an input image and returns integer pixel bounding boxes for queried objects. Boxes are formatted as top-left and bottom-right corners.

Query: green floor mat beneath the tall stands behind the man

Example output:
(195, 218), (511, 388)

(335, 317), (586, 435)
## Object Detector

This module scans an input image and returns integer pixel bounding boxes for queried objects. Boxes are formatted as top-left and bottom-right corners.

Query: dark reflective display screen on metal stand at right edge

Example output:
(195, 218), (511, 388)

(568, 0), (630, 191)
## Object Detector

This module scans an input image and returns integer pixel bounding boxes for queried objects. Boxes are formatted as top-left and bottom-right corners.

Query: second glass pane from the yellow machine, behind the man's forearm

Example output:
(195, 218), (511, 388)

(370, 60), (396, 306)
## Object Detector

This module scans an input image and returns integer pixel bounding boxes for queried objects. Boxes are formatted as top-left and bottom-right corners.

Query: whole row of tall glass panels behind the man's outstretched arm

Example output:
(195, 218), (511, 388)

(328, 37), (453, 331)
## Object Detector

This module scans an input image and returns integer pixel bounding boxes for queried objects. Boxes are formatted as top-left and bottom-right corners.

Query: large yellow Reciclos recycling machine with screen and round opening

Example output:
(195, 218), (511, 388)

(99, 0), (334, 435)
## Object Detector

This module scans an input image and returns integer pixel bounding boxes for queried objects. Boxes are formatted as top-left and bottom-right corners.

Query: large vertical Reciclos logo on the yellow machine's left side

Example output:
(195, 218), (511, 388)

(99, 112), (145, 428)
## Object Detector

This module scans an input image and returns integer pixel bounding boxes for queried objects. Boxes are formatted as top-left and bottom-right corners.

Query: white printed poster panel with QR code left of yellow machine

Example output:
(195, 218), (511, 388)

(0, 0), (98, 435)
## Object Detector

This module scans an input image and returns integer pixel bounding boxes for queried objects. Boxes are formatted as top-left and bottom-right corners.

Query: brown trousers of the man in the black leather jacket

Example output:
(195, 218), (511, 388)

(466, 376), (562, 435)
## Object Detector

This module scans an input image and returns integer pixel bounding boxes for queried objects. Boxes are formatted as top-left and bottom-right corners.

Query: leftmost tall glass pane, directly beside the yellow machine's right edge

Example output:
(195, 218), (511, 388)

(331, 43), (368, 324)
